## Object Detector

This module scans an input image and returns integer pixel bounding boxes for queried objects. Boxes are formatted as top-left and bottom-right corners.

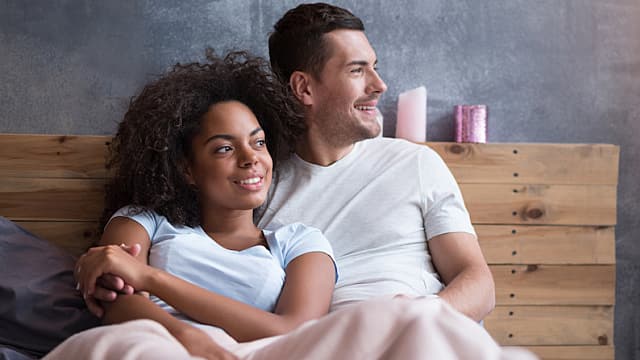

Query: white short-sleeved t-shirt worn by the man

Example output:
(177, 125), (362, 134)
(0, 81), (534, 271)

(259, 138), (475, 310)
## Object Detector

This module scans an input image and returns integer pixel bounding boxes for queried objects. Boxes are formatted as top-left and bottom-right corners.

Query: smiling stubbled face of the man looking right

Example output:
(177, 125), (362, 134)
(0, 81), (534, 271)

(308, 30), (387, 147)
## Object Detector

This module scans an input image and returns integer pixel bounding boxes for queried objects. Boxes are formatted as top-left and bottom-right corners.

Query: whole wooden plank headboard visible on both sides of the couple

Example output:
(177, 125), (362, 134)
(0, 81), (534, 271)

(0, 134), (619, 359)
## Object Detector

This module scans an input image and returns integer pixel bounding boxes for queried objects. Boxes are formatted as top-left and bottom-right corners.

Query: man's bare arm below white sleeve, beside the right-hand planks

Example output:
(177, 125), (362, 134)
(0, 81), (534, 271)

(428, 232), (496, 321)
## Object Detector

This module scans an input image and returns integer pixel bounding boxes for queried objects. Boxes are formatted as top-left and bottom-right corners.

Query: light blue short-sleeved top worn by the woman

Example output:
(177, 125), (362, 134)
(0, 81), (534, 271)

(112, 207), (337, 320)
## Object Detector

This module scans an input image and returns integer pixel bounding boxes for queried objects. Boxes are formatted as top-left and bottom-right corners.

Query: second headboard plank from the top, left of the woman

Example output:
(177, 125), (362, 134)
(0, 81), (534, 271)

(0, 177), (104, 221)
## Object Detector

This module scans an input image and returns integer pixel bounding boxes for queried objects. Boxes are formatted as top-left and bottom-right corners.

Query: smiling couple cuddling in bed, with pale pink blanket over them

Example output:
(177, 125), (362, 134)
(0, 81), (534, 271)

(47, 4), (529, 359)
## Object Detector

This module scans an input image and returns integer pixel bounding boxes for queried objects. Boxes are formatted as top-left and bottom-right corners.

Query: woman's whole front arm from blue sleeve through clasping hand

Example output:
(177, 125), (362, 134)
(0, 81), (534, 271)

(81, 240), (335, 341)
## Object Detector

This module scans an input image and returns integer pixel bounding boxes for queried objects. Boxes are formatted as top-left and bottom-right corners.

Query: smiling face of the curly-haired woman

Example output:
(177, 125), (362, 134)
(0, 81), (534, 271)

(186, 100), (273, 211)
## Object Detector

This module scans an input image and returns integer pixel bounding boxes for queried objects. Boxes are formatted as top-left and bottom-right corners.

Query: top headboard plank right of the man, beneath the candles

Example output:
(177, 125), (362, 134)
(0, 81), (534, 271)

(427, 142), (620, 185)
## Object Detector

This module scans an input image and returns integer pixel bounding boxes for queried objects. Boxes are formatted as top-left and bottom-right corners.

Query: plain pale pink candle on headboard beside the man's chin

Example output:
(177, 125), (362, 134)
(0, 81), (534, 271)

(396, 86), (427, 142)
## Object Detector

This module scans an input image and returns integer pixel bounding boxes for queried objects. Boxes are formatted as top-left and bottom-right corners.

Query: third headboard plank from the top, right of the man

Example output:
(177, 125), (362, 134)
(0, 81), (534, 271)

(475, 225), (616, 264)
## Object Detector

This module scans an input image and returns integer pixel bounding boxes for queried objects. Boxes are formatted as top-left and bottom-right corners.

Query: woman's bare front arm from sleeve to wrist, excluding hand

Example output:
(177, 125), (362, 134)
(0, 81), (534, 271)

(147, 252), (335, 342)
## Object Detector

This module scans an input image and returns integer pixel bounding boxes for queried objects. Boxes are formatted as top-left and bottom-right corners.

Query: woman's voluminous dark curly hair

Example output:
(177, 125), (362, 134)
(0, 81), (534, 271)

(100, 49), (305, 229)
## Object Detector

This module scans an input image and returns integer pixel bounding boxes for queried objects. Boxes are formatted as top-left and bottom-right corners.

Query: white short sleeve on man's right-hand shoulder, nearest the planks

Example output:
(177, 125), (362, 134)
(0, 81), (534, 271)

(418, 147), (476, 239)
